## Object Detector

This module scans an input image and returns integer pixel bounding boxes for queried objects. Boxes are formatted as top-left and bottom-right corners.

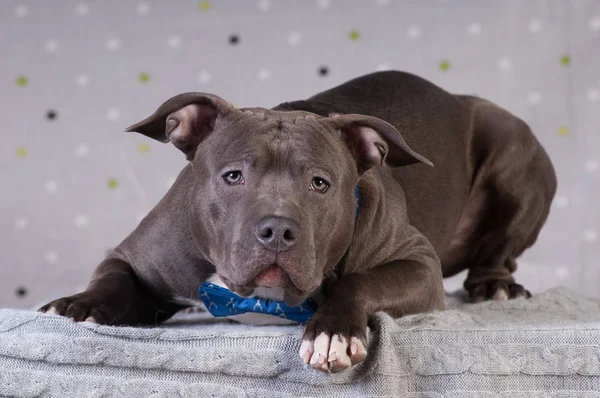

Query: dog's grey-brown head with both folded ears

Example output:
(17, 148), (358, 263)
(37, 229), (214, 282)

(127, 93), (429, 305)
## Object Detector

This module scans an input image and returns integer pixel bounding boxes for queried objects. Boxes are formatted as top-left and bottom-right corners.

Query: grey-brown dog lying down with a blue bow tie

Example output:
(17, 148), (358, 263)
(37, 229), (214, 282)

(40, 71), (557, 372)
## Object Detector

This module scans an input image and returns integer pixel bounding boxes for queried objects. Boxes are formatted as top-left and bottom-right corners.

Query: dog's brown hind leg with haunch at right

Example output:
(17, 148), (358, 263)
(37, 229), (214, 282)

(464, 99), (556, 302)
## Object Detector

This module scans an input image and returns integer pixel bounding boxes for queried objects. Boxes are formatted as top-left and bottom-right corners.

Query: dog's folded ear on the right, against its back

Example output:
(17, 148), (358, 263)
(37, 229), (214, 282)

(329, 114), (433, 174)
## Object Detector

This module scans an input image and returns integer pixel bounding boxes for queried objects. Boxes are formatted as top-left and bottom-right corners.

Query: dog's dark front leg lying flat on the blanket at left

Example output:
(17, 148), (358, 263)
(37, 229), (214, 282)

(39, 259), (182, 325)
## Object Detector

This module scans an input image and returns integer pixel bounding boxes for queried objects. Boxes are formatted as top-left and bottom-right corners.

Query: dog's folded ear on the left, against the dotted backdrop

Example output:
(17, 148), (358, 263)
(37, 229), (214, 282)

(125, 93), (234, 161)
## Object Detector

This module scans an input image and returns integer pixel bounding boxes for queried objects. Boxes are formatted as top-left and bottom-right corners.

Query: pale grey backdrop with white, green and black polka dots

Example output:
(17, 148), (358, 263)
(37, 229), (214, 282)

(0, 0), (600, 306)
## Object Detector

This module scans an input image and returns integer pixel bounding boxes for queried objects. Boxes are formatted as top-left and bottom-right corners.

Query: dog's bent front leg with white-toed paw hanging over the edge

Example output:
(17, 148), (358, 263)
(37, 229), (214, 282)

(299, 260), (444, 373)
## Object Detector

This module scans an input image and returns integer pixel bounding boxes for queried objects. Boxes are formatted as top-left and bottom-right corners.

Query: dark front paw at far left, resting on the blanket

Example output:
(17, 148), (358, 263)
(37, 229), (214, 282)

(38, 292), (116, 325)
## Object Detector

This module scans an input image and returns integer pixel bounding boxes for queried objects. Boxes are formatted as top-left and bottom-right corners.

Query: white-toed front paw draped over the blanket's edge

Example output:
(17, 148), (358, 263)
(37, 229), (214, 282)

(299, 311), (367, 373)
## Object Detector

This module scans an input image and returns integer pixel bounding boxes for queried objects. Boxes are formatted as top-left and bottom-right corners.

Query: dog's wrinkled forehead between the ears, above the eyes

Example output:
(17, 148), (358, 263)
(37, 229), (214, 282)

(202, 108), (349, 171)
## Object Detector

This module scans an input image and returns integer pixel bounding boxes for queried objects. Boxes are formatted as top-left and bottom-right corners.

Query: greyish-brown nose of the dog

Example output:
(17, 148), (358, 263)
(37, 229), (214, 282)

(256, 217), (300, 251)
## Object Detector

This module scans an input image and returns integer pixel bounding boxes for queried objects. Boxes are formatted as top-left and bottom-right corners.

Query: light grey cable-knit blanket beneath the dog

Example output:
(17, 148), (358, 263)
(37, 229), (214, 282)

(0, 288), (600, 398)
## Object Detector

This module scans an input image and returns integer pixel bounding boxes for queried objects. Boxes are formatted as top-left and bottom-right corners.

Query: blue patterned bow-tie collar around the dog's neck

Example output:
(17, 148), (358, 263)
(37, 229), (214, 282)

(198, 186), (360, 323)
